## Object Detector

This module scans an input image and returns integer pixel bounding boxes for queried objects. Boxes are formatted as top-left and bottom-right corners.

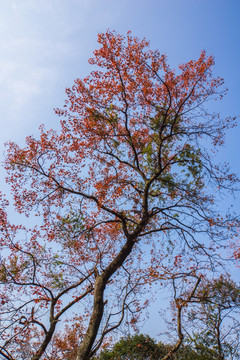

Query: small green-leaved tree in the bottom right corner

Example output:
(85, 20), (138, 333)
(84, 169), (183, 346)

(186, 276), (240, 360)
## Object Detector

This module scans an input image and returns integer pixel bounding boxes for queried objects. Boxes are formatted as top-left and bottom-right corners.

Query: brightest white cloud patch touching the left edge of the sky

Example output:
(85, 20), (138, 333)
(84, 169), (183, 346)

(0, 38), (57, 121)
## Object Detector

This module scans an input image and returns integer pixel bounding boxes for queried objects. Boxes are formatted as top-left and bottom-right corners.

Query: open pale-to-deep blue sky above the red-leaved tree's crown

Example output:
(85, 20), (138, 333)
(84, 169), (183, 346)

(0, 0), (240, 335)
